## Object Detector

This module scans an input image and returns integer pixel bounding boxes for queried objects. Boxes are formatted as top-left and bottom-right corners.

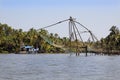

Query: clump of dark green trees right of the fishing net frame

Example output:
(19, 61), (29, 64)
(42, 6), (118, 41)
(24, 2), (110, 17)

(93, 26), (120, 54)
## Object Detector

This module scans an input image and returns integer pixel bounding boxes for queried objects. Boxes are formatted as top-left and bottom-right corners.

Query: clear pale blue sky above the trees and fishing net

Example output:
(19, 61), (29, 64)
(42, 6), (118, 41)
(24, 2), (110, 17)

(0, 0), (120, 39)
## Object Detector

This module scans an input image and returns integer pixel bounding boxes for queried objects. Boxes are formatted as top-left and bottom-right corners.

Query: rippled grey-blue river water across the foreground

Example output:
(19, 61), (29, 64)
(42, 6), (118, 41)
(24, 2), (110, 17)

(0, 54), (120, 80)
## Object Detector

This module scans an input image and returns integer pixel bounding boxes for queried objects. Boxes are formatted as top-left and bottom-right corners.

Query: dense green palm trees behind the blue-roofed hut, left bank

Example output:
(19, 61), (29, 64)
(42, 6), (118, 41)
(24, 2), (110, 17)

(0, 23), (67, 53)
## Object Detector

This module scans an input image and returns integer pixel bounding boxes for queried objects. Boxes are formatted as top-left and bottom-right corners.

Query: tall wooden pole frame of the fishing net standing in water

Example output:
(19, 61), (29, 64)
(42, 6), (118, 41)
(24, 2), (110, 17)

(37, 16), (98, 56)
